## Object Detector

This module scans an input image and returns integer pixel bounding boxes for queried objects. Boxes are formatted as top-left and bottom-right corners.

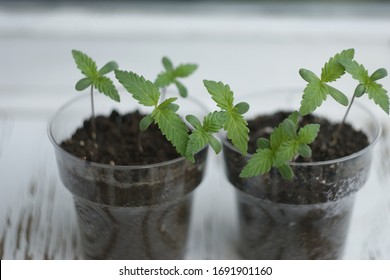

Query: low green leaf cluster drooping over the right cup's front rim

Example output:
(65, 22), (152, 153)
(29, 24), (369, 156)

(240, 112), (320, 180)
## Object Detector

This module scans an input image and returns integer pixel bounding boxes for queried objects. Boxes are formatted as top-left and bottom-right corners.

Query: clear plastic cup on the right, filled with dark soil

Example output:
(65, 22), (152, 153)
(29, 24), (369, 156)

(223, 90), (381, 259)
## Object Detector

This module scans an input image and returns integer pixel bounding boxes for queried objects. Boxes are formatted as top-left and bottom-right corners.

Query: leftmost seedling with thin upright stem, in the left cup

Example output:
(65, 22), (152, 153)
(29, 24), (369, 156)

(72, 50), (120, 139)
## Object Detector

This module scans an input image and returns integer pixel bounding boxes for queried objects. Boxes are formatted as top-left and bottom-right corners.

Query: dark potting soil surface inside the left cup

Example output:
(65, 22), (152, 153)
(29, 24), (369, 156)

(61, 111), (180, 165)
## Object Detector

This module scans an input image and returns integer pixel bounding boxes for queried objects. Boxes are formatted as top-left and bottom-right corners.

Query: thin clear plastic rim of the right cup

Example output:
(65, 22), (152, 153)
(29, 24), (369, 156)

(219, 88), (382, 166)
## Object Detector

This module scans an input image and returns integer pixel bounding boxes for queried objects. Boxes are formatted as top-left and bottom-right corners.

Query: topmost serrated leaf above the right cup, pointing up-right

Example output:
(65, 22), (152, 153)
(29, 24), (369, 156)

(321, 49), (354, 82)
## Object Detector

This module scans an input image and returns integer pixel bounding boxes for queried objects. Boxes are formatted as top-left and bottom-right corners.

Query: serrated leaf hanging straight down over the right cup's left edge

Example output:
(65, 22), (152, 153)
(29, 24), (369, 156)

(224, 110), (249, 155)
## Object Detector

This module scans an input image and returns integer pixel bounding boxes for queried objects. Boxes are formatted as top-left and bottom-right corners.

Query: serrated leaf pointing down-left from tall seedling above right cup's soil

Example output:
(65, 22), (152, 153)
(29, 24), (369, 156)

(299, 82), (328, 116)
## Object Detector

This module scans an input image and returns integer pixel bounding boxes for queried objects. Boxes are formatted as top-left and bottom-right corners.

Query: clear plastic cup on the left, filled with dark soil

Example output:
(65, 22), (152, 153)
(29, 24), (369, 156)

(48, 94), (207, 259)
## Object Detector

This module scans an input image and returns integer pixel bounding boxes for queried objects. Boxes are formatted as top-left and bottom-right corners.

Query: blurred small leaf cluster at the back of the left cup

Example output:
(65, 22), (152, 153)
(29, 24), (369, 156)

(154, 56), (198, 97)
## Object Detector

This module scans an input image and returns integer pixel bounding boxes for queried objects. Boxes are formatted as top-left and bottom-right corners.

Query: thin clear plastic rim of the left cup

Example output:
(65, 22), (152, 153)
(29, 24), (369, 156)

(47, 91), (208, 170)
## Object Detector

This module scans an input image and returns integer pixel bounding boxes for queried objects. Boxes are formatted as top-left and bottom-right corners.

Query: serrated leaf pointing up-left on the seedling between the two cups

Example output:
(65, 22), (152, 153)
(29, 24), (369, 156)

(203, 80), (234, 110)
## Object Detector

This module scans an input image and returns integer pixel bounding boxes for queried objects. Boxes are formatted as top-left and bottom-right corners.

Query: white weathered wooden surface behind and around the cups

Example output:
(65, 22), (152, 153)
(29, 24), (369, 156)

(0, 4), (390, 259)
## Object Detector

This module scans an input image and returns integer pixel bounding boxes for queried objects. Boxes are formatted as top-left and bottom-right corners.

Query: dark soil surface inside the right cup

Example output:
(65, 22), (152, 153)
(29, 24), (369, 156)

(248, 112), (369, 162)
